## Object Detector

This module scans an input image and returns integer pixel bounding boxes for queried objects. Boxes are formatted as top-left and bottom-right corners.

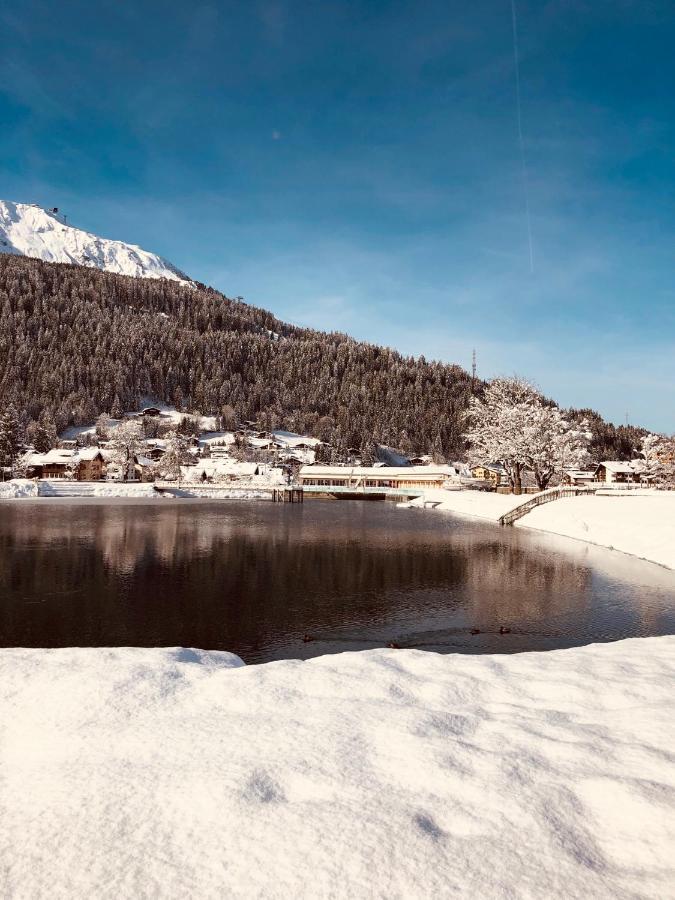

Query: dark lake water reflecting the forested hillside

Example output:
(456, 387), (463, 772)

(0, 500), (675, 662)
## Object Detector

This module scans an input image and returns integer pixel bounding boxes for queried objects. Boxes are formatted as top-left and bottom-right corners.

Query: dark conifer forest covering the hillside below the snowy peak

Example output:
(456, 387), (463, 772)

(0, 254), (645, 460)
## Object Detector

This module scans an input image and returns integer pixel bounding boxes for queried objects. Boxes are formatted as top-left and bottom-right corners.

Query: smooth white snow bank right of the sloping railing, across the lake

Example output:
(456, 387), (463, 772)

(516, 491), (675, 569)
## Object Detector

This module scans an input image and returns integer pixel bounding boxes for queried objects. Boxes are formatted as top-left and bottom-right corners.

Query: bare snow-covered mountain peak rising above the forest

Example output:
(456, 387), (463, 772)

(0, 200), (190, 282)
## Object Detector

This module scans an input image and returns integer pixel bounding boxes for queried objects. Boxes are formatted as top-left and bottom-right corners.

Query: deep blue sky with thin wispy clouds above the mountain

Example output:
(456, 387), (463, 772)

(0, 0), (675, 432)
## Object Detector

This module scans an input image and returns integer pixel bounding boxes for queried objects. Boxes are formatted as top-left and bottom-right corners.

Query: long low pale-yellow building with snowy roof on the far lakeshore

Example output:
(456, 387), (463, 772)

(298, 466), (459, 491)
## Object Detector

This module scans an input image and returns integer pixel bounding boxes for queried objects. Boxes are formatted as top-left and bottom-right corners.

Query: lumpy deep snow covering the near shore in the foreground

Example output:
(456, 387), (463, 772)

(0, 637), (675, 900)
